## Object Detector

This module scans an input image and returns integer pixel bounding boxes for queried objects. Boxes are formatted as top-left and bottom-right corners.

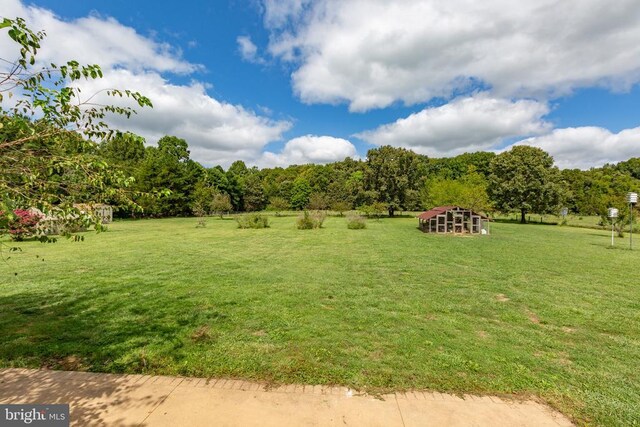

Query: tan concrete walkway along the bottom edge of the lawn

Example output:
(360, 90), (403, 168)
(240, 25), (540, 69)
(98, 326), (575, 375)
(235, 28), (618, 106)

(0, 369), (572, 427)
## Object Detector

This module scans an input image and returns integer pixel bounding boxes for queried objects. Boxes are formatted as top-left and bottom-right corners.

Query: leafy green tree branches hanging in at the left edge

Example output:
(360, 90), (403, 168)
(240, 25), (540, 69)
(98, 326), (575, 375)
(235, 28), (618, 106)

(0, 18), (152, 244)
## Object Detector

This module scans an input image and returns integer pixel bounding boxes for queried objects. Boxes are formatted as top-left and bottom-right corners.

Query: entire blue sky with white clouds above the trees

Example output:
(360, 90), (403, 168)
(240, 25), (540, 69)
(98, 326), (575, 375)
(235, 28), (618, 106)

(0, 0), (640, 169)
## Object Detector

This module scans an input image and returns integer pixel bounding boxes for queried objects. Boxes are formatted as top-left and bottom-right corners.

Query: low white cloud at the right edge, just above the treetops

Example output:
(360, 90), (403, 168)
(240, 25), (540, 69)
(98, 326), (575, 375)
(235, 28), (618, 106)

(516, 127), (640, 169)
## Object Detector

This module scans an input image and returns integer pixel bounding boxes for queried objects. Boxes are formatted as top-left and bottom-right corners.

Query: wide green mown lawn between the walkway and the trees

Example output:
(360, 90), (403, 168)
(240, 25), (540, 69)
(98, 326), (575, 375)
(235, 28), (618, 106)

(0, 217), (640, 425)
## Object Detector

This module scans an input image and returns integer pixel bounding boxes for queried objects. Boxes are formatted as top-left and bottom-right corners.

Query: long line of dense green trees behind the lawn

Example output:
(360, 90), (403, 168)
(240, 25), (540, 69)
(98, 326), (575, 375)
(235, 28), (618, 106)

(92, 133), (640, 221)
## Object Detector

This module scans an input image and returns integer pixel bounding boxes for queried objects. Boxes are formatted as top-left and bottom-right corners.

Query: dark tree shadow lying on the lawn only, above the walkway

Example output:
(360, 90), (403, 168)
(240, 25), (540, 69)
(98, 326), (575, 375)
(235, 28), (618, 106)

(0, 289), (188, 373)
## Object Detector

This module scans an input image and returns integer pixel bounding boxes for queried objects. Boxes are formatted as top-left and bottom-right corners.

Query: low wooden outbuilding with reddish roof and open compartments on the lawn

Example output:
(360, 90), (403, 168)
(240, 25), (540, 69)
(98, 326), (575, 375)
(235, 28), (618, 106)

(418, 206), (490, 234)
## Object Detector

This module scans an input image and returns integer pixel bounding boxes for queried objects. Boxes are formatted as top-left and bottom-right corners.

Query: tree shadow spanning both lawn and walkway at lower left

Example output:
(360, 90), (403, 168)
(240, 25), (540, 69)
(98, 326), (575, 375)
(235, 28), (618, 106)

(0, 280), (175, 426)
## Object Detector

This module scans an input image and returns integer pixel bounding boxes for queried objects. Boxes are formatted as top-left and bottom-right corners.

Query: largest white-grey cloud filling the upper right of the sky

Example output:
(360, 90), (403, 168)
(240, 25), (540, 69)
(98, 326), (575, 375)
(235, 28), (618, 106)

(265, 0), (640, 111)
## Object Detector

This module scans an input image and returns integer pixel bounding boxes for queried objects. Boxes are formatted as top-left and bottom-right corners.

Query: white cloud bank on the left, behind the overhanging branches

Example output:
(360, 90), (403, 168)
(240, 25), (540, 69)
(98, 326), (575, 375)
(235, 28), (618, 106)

(0, 0), (291, 165)
